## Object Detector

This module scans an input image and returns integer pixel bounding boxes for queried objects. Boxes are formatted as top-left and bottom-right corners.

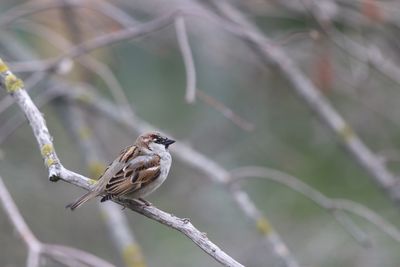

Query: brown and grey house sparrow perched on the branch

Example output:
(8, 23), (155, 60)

(66, 132), (175, 210)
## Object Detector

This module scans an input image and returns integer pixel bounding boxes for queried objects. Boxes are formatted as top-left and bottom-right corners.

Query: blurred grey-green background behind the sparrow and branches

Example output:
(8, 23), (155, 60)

(0, 0), (400, 267)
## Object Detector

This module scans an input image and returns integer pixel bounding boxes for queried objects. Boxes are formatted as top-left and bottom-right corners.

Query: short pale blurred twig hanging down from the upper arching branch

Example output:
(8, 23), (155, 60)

(175, 16), (196, 103)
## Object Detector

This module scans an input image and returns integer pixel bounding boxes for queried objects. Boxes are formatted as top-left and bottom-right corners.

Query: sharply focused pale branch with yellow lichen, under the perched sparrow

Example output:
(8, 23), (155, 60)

(0, 57), (243, 266)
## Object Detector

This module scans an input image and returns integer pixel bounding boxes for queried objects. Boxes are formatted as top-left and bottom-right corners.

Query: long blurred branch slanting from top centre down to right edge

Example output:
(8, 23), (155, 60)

(208, 1), (400, 202)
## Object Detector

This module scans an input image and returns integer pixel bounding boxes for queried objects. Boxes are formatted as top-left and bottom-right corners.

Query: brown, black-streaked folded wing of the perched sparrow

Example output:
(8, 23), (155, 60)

(104, 148), (160, 196)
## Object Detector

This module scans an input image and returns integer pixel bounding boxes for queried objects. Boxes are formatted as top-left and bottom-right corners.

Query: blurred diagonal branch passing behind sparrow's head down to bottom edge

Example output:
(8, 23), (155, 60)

(60, 82), (299, 267)
